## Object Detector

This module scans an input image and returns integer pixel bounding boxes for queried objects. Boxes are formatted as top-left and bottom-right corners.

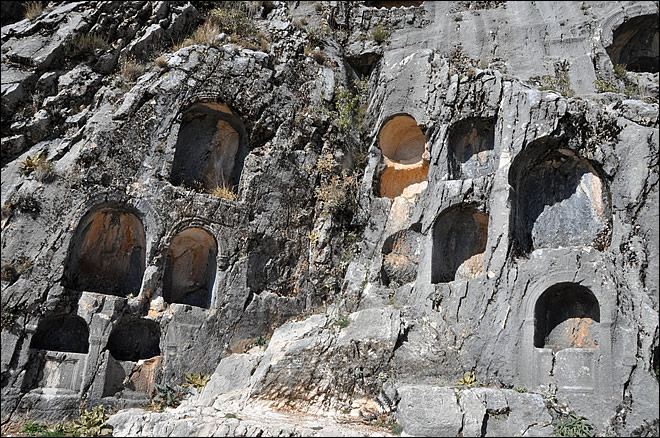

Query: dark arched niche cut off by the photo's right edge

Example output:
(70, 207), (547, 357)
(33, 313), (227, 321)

(605, 14), (660, 73)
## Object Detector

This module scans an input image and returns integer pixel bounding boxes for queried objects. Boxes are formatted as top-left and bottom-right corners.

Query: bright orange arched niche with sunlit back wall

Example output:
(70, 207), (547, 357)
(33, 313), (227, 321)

(378, 114), (429, 198)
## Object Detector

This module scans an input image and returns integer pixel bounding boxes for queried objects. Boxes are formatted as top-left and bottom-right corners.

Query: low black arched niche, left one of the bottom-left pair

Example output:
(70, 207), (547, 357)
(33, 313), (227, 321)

(30, 315), (89, 354)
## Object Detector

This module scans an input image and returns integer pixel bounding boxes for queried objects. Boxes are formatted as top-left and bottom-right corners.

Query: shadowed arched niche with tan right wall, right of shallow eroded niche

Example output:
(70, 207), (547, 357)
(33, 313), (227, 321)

(431, 205), (488, 283)
